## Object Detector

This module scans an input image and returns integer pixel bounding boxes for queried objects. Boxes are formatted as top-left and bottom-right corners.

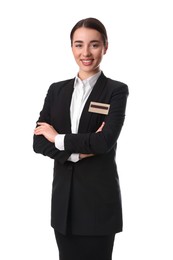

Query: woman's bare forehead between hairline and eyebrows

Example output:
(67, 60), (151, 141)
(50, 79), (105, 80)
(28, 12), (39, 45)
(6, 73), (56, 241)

(73, 27), (102, 42)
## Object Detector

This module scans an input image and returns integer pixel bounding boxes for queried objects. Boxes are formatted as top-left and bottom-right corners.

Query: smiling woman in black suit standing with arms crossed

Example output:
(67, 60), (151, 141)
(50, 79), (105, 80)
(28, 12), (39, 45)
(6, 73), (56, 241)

(33, 18), (128, 260)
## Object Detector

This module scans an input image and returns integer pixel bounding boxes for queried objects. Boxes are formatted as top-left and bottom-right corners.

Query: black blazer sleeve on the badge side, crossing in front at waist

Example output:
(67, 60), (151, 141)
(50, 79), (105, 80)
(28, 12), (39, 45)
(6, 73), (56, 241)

(64, 84), (129, 154)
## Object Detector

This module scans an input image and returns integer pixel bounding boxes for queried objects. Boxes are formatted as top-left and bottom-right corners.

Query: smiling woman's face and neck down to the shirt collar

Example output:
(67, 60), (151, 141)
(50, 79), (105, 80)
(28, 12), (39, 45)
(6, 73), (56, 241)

(72, 27), (107, 79)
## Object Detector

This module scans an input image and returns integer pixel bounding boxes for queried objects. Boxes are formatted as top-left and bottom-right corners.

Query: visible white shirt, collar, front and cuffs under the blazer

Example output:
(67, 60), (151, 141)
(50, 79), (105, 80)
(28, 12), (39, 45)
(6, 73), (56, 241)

(55, 71), (101, 162)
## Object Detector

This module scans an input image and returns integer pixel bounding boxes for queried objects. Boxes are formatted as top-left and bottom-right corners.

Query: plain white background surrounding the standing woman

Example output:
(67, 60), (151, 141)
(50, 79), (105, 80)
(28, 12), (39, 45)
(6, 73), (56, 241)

(0, 0), (173, 260)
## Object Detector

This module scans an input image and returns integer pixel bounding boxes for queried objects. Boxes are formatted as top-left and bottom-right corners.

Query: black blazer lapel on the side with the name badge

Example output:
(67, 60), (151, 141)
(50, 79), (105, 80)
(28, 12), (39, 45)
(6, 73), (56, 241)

(78, 72), (107, 133)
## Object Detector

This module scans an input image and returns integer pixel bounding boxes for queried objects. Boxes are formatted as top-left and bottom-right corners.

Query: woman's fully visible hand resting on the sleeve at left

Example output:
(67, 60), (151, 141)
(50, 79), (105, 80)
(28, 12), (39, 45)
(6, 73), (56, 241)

(34, 122), (58, 143)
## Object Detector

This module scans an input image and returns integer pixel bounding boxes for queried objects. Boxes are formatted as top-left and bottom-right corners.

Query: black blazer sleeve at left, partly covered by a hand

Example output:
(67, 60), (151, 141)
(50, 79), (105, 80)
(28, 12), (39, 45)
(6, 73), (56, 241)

(33, 84), (71, 164)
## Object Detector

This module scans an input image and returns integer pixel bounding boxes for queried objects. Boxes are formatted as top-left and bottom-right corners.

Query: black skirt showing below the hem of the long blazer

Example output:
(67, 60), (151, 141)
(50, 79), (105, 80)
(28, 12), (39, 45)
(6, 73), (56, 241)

(55, 230), (115, 260)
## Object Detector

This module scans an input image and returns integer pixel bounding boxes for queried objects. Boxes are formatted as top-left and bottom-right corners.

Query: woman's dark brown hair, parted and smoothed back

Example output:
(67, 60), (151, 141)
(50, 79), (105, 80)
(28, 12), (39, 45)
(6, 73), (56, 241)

(70, 18), (108, 45)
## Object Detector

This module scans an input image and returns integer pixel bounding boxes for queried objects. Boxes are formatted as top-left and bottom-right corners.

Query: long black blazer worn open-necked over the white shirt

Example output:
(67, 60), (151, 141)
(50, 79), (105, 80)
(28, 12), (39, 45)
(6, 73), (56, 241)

(33, 72), (128, 235)
